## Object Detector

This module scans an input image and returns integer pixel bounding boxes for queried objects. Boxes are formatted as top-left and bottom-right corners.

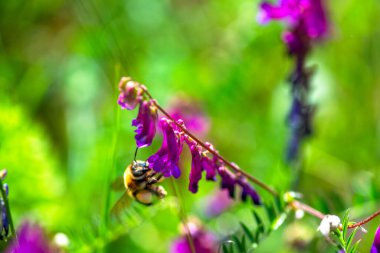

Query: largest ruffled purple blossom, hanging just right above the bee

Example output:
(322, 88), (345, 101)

(148, 118), (183, 178)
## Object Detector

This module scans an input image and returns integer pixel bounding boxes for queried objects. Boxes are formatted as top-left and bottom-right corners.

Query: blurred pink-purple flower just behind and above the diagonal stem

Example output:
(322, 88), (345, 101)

(168, 96), (210, 135)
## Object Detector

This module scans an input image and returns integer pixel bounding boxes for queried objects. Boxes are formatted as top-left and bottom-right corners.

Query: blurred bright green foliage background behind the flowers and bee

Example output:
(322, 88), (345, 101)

(0, 0), (380, 253)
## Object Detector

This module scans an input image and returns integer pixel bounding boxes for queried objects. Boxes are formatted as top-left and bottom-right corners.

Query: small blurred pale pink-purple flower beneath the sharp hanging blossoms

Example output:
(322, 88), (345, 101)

(204, 189), (234, 217)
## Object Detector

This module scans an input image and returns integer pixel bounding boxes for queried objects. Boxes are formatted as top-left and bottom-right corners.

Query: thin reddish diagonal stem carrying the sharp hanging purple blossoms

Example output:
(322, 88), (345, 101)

(140, 85), (278, 196)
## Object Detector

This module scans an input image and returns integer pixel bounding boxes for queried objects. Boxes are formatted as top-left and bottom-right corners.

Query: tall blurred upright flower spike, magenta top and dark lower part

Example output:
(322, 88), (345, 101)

(258, 0), (329, 161)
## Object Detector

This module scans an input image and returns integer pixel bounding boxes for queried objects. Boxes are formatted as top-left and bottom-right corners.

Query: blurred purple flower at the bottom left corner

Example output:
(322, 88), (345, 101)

(5, 222), (53, 253)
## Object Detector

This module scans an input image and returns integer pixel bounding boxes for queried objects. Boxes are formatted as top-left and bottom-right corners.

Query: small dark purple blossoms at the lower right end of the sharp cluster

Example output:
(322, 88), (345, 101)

(219, 167), (261, 205)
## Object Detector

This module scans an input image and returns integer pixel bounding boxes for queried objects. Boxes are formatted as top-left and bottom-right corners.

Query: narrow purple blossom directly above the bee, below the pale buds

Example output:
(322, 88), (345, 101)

(132, 100), (157, 148)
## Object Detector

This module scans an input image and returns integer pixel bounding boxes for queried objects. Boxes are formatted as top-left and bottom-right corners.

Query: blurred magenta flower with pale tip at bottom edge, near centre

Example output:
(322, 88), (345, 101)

(170, 217), (217, 253)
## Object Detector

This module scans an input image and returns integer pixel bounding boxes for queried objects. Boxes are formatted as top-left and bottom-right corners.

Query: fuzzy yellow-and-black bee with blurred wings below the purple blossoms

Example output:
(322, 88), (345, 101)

(111, 157), (167, 216)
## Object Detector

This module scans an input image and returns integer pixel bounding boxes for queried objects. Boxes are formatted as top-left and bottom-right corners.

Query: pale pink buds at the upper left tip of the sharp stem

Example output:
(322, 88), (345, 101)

(117, 77), (143, 110)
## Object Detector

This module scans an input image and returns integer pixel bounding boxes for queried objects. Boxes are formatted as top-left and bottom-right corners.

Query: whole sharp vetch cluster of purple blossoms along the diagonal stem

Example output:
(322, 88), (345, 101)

(118, 77), (261, 205)
